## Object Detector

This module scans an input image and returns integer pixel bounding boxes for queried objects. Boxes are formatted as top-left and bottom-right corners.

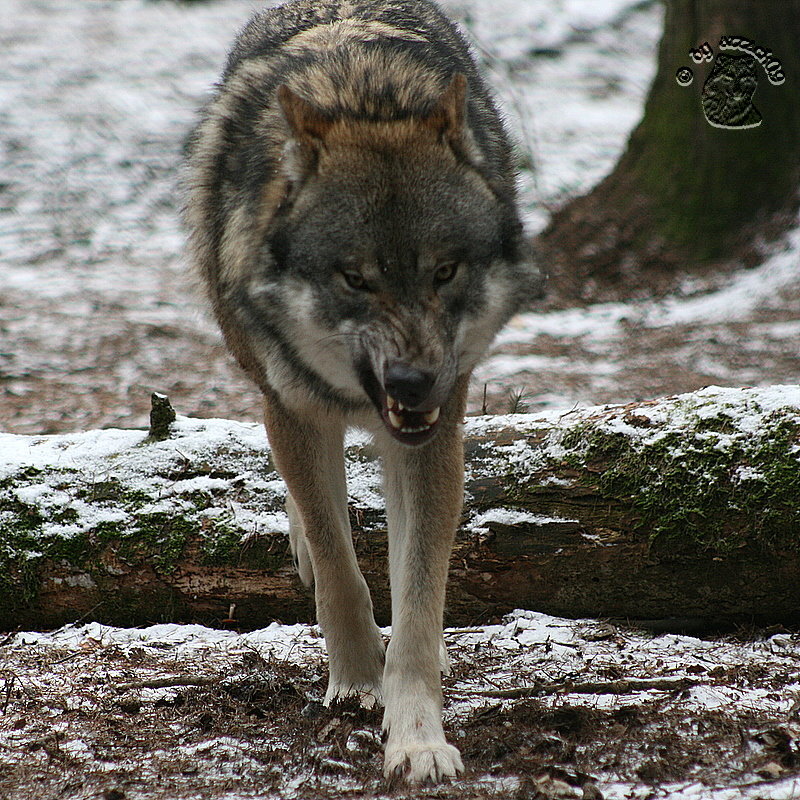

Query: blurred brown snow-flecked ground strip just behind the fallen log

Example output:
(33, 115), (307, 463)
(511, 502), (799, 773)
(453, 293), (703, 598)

(6, 242), (800, 434)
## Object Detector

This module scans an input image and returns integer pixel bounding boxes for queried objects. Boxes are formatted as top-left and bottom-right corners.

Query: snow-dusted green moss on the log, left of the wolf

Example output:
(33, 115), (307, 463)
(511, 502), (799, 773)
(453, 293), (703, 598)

(0, 444), (285, 609)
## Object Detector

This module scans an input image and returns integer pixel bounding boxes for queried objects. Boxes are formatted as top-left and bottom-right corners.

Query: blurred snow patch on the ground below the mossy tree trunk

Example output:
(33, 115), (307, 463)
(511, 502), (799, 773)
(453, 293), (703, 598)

(482, 219), (800, 407)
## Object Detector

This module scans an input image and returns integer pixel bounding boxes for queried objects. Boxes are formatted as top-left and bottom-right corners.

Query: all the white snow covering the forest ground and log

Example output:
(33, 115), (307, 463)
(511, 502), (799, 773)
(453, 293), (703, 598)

(0, 0), (800, 800)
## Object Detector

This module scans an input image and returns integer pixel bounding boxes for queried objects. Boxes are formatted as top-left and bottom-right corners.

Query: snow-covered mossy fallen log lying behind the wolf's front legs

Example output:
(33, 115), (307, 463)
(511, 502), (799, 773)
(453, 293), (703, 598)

(0, 387), (800, 630)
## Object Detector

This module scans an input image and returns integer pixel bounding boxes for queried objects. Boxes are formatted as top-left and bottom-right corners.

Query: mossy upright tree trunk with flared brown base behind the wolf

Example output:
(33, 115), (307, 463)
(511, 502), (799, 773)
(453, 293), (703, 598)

(540, 0), (800, 300)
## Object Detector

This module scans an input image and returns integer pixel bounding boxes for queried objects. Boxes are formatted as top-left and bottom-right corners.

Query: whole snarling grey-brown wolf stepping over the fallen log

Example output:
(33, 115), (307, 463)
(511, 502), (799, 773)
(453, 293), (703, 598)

(185, 0), (539, 783)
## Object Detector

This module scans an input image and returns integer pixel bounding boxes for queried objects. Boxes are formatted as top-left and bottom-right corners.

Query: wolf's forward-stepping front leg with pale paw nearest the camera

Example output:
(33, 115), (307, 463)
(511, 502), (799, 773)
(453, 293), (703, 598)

(383, 381), (466, 783)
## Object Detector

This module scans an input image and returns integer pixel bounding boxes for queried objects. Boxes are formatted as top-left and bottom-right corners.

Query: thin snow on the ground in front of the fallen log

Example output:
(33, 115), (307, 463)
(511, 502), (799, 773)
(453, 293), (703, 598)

(6, 611), (800, 800)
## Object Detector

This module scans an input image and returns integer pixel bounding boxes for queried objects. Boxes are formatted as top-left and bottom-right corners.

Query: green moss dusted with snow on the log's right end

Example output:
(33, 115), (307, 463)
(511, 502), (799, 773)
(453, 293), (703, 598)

(544, 404), (800, 554)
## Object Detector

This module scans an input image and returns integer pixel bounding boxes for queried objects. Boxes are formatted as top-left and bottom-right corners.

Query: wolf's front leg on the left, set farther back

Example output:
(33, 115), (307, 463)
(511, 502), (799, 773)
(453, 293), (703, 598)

(264, 398), (384, 707)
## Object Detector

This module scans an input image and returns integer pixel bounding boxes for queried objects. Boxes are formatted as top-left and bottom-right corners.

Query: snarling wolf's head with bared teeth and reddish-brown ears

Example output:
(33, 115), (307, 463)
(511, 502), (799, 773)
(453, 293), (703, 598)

(256, 74), (534, 444)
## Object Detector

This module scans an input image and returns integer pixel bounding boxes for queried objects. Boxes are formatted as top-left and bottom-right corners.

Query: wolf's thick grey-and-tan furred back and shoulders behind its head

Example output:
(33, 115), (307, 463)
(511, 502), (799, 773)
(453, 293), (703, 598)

(185, 0), (528, 398)
